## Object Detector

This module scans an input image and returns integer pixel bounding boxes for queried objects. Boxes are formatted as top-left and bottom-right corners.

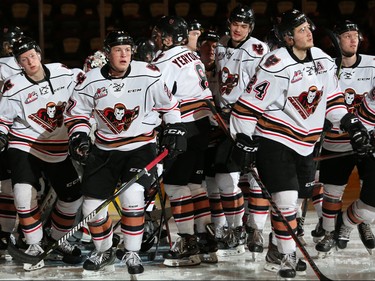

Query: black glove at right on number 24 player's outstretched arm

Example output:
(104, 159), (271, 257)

(340, 113), (371, 158)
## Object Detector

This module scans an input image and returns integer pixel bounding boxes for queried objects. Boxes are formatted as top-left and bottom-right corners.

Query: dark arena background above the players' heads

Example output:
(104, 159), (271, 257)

(0, 0), (375, 68)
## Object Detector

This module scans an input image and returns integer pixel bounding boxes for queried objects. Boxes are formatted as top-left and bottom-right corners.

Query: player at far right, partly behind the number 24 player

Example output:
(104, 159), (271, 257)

(315, 20), (375, 252)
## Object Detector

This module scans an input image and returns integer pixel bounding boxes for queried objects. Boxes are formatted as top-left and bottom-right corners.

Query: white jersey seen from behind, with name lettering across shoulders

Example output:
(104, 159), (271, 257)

(152, 46), (212, 123)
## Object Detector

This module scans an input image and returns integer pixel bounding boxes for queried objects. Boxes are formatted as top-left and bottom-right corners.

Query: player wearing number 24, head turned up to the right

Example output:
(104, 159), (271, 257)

(230, 10), (369, 278)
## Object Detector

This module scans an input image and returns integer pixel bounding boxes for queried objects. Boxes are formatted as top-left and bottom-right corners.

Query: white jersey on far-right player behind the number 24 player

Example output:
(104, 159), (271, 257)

(323, 55), (375, 152)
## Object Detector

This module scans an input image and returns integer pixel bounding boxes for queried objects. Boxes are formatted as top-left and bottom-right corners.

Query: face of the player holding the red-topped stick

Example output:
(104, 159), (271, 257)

(108, 45), (132, 73)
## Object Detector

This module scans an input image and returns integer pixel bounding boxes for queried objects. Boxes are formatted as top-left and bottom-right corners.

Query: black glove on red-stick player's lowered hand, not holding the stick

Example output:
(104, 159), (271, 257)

(69, 132), (91, 164)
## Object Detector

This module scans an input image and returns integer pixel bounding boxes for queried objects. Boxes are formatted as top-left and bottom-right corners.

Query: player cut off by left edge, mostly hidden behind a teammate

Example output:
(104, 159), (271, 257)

(0, 26), (23, 257)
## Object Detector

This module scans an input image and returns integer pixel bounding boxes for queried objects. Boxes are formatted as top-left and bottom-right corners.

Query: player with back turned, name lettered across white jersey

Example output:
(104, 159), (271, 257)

(152, 16), (217, 266)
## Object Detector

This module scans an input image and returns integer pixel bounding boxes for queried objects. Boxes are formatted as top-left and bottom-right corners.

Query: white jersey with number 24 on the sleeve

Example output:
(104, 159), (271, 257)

(230, 47), (348, 156)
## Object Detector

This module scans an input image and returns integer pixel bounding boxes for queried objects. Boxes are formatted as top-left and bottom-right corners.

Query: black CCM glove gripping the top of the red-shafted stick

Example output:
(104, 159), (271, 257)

(161, 123), (187, 158)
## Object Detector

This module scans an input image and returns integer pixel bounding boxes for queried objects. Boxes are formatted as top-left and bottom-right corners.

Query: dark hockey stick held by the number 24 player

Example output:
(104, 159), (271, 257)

(207, 101), (331, 280)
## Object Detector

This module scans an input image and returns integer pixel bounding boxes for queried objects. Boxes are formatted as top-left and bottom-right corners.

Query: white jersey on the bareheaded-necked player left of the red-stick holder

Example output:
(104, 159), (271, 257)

(0, 63), (80, 163)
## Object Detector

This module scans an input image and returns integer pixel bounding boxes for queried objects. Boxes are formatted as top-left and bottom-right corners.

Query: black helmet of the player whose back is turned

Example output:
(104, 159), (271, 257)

(155, 16), (189, 45)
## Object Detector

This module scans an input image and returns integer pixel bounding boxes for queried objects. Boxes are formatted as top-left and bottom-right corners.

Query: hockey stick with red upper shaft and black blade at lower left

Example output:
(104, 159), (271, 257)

(8, 149), (168, 265)
